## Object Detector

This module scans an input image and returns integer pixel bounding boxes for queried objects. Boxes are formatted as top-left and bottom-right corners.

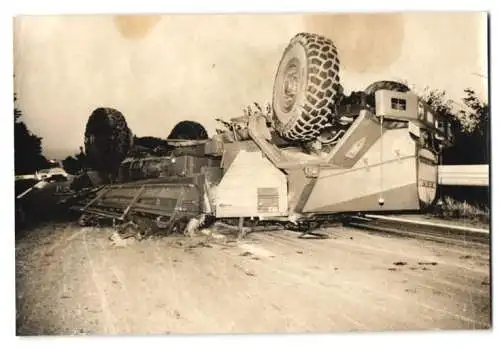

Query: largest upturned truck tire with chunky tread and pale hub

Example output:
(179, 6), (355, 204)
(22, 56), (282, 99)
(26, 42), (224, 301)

(273, 33), (342, 142)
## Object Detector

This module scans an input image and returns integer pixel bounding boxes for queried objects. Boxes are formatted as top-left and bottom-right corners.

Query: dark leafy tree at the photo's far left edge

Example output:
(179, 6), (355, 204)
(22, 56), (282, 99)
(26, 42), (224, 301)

(14, 94), (49, 174)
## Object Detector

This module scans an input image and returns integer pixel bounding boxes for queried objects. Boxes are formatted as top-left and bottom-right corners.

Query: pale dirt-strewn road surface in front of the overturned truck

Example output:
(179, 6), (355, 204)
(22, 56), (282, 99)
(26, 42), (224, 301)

(16, 224), (490, 335)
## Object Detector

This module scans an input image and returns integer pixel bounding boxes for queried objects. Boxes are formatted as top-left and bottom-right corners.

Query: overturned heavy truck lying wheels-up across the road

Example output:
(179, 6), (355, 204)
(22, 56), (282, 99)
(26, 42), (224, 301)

(65, 33), (452, 237)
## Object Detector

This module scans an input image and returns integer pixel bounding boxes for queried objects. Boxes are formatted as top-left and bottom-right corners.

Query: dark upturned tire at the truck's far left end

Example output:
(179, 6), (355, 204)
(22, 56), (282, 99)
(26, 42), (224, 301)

(85, 108), (133, 174)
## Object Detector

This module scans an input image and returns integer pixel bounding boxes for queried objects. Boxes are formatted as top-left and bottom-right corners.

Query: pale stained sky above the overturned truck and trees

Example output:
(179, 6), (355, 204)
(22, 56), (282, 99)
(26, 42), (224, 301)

(14, 12), (488, 159)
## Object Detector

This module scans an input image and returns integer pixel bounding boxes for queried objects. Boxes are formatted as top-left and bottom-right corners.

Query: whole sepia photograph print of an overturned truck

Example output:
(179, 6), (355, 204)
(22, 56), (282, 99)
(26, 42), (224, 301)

(9, 11), (493, 336)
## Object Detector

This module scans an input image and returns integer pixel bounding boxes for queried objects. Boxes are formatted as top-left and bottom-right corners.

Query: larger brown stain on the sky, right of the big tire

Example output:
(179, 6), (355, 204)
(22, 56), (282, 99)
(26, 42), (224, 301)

(304, 13), (405, 72)
